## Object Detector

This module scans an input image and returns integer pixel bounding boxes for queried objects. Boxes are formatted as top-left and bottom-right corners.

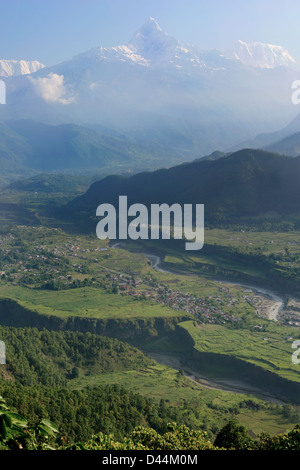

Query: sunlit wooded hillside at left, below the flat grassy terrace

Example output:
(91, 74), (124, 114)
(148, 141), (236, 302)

(0, 326), (152, 387)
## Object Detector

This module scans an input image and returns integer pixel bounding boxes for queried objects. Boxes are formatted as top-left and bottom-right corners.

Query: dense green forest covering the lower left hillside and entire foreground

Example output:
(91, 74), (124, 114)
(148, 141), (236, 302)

(0, 326), (300, 450)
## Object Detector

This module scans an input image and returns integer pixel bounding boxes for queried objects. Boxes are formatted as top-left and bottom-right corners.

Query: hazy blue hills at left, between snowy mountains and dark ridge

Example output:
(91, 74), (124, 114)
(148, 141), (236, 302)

(0, 119), (217, 186)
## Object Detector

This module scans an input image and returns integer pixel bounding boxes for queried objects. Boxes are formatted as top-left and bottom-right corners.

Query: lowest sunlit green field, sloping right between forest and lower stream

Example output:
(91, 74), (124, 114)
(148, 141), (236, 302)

(69, 356), (299, 435)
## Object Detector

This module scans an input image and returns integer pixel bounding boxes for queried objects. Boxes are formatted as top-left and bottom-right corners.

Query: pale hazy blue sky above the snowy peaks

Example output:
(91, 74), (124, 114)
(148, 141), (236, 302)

(0, 0), (300, 65)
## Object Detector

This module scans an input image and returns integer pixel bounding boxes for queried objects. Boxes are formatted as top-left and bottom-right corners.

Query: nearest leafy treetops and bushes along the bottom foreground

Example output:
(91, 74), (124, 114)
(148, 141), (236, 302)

(0, 396), (300, 452)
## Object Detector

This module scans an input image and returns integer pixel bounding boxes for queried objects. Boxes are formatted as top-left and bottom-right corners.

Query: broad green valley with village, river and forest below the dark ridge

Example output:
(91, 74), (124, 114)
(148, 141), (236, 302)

(0, 149), (300, 445)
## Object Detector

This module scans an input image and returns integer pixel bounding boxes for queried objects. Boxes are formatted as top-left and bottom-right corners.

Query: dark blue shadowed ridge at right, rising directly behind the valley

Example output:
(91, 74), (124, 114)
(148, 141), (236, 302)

(67, 149), (300, 223)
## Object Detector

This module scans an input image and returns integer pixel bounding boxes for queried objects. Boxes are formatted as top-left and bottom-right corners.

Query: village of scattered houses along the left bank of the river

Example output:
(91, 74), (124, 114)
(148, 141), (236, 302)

(0, 230), (298, 324)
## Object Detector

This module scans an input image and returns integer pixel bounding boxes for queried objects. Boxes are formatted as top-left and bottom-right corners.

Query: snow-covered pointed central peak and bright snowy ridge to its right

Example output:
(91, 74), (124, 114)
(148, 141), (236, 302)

(73, 17), (295, 73)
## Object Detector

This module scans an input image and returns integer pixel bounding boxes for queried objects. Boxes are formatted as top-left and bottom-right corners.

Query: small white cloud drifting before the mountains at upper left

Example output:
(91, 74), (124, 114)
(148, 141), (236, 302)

(28, 72), (74, 104)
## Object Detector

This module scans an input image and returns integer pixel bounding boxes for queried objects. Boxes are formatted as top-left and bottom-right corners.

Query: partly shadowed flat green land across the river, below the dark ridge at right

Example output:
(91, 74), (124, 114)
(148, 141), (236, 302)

(128, 228), (300, 297)
